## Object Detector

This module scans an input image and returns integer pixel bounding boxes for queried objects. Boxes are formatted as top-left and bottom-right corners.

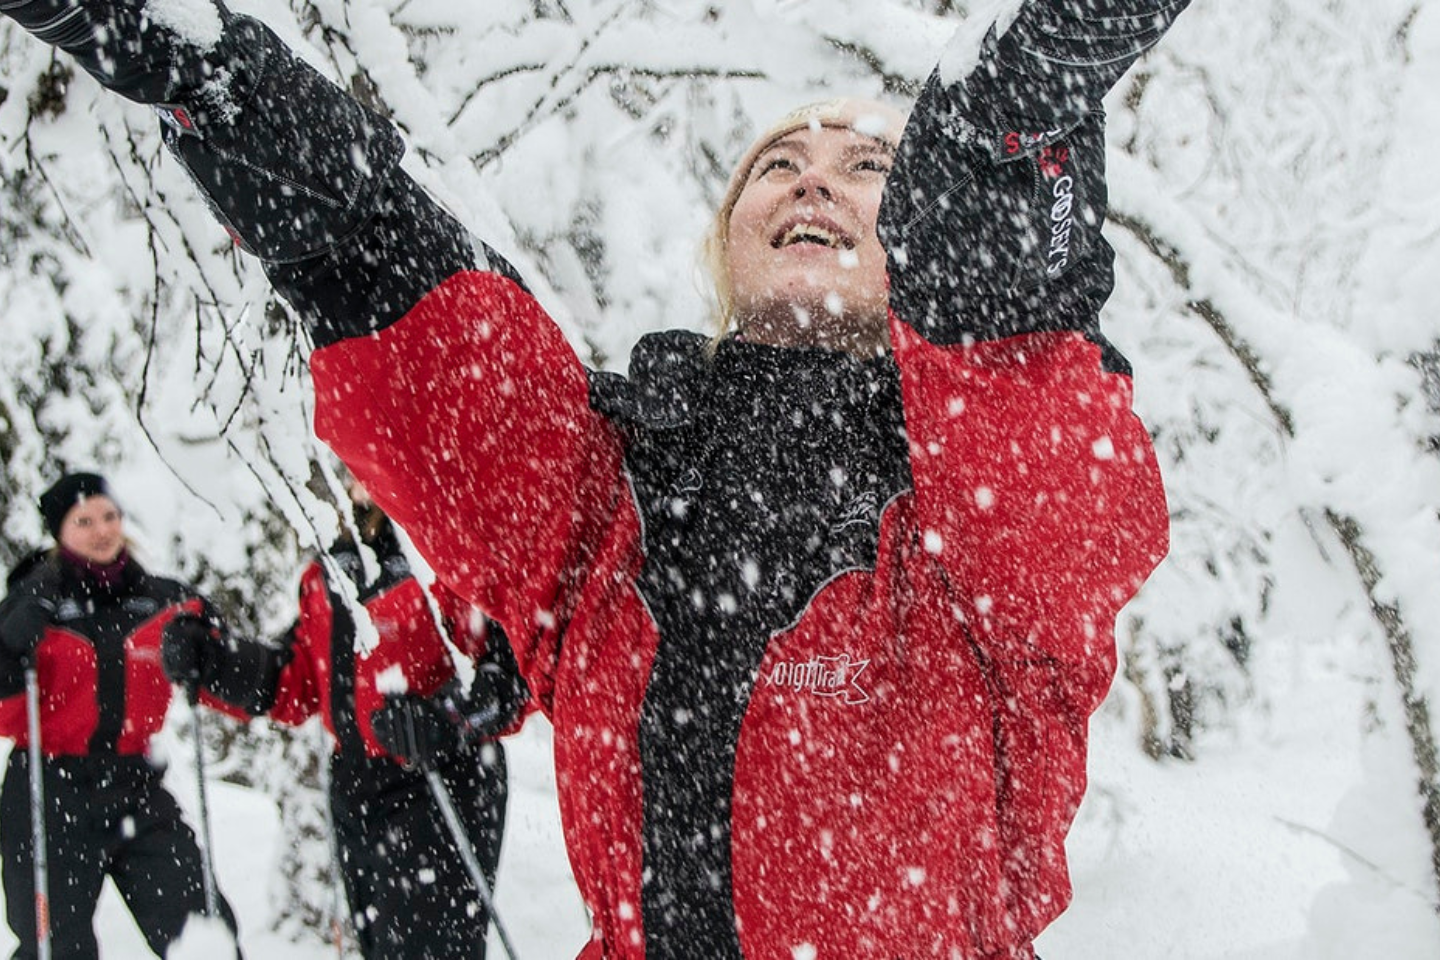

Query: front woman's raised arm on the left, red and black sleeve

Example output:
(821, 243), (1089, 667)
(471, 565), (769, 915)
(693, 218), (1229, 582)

(0, 0), (624, 693)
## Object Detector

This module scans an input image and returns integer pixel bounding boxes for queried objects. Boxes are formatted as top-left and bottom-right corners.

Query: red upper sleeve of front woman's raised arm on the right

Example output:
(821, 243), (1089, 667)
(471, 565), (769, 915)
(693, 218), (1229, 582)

(894, 324), (1168, 673)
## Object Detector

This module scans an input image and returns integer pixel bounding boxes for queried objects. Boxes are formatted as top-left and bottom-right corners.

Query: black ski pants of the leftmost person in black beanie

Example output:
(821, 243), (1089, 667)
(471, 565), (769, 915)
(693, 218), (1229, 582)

(0, 748), (236, 960)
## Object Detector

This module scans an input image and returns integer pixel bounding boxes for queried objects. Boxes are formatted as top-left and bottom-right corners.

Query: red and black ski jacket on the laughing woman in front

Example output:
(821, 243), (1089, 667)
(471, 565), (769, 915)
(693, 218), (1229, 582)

(241, 0), (1185, 960)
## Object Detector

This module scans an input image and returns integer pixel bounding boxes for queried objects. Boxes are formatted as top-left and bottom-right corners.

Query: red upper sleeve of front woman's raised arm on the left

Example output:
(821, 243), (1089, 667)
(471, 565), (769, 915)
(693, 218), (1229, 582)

(311, 272), (625, 699)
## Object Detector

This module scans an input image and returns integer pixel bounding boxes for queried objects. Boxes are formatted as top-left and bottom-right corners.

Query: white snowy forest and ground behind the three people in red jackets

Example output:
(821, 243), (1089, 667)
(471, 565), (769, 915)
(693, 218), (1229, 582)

(0, 0), (1440, 960)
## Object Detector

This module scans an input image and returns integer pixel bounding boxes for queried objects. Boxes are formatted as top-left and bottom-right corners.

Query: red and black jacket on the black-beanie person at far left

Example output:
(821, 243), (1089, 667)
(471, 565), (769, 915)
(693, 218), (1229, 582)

(0, 556), (216, 757)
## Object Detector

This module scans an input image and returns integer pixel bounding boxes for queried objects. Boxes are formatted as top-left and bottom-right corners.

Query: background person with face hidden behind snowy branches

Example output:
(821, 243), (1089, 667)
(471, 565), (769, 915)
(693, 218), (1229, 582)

(163, 488), (527, 960)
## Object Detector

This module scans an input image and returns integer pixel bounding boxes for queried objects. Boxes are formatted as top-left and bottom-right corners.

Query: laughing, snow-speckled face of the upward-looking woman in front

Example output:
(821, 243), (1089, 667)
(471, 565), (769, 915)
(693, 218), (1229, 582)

(726, 127), (891, 353)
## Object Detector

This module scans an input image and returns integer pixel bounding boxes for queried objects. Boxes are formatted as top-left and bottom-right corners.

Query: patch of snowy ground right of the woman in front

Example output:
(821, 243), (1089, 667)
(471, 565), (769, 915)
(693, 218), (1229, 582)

(1040, 630), (1440, 960)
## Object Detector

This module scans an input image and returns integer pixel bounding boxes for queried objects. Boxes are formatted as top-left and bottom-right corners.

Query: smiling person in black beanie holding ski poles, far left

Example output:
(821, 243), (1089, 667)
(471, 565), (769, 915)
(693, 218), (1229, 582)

(0, 474), (239, 960)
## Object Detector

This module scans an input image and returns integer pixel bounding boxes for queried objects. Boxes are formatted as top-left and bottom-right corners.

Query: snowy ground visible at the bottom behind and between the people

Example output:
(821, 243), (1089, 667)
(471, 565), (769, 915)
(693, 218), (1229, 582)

(0, 630), (1440, 960)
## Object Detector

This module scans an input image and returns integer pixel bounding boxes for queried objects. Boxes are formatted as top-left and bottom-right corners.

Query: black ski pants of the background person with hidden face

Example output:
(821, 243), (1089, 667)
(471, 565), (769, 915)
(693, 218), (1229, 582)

(330, 743), (507, 960)
